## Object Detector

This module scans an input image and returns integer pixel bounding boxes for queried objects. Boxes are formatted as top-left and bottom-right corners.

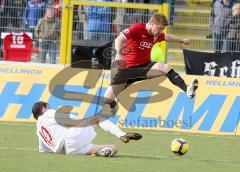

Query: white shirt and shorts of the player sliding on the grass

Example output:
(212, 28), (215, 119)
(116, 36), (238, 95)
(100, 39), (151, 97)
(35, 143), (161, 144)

(37, 109), (96, 154)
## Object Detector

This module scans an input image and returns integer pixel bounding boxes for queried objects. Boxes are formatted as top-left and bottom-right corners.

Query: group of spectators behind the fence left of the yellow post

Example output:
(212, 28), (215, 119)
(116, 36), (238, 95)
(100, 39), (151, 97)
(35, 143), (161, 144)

(0, 0), (62, 63)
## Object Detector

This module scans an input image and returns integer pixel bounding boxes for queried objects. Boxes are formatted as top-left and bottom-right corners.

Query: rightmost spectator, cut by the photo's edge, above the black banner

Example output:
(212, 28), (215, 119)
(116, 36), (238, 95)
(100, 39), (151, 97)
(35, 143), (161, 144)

(227, 3), (240, 52)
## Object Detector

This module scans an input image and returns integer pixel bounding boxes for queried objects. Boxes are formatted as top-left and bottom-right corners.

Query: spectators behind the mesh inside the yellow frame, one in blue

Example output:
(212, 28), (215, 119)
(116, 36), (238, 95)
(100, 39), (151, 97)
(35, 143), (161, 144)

(73, 0), (165, 40)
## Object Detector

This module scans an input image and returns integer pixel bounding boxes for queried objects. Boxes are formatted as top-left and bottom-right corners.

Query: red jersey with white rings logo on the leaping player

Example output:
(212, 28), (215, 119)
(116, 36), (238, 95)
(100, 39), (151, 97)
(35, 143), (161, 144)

(122, 23), (165, 67)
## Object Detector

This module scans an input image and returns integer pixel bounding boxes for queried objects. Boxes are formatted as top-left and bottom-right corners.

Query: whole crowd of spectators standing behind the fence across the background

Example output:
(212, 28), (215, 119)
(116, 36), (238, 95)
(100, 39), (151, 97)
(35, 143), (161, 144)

(0, 0), (240, 63)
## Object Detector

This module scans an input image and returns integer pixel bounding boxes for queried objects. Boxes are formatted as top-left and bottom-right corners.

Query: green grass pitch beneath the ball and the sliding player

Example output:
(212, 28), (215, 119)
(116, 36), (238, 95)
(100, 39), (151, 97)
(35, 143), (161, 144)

(0, 122), (240, 172)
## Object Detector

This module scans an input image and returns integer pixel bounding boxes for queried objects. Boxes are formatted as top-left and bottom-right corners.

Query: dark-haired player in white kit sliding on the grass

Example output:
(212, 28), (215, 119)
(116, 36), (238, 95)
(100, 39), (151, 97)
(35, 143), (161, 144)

(32, 101), (142, 157)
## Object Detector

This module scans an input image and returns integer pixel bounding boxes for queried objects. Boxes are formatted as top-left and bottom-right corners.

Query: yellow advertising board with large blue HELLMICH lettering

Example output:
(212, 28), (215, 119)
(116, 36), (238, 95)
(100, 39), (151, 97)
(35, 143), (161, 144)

(0, 63), (240, 135)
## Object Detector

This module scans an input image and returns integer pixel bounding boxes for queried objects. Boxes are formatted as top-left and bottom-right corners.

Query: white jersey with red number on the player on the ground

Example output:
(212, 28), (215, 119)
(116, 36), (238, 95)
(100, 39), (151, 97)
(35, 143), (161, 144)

(37, 109), (68, 153)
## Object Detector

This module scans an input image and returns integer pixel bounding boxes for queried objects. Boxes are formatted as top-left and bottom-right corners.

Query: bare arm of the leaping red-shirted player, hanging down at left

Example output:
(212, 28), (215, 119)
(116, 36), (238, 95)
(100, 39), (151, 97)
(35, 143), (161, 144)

(114, 33), (126, 68)
